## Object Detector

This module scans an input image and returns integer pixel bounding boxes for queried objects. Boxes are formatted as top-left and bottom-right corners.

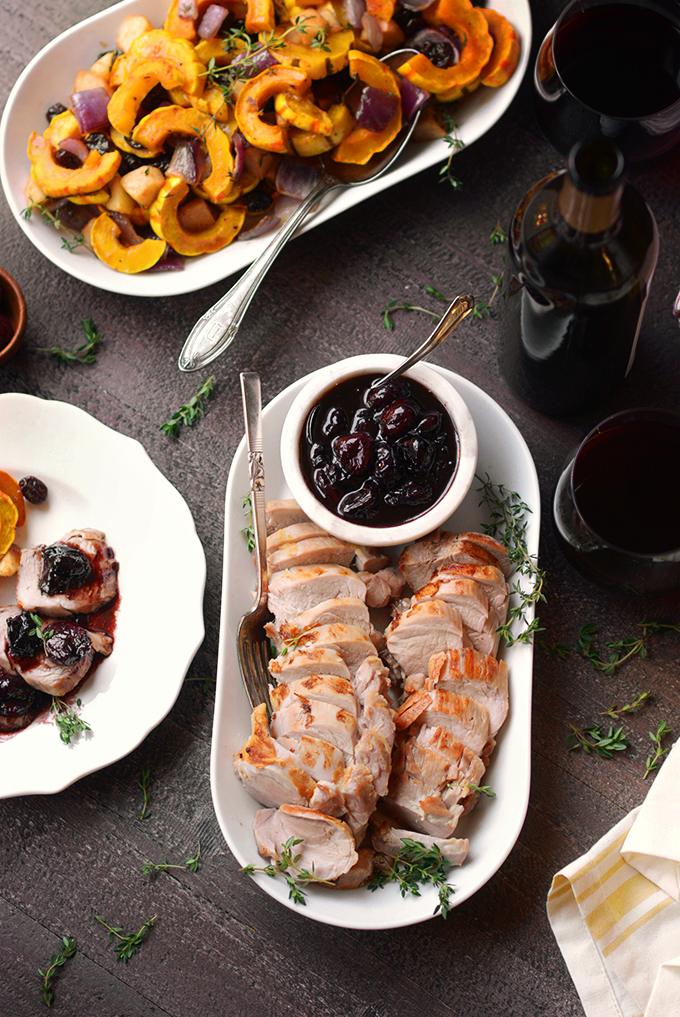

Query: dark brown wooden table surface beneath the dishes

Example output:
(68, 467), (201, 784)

(0, 0), (680, 1017)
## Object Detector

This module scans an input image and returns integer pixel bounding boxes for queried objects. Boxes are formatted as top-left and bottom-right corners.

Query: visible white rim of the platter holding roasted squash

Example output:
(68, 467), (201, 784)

(0, 0), (532, 297)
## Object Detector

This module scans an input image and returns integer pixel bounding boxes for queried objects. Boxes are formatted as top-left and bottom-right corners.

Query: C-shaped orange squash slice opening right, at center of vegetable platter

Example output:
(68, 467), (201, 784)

(234, 66), (312, 152)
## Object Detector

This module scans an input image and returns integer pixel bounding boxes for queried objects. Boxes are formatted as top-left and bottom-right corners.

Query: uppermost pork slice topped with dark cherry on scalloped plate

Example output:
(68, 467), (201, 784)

(16, 529), (118, 618)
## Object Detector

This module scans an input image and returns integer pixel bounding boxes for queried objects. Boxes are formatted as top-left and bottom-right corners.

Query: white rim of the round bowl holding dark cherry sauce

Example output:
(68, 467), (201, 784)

(281, 353), (477, 547)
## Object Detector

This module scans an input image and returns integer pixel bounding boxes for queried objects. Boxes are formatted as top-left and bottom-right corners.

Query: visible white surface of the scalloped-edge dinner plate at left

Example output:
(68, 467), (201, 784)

(0, 393), (205, 797)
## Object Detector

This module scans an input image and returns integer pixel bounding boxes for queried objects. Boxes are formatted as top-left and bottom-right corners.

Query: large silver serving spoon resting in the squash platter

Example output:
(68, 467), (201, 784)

(179, 49), (421, 371)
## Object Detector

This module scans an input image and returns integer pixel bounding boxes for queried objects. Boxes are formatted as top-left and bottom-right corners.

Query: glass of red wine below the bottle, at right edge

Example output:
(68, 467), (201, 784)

(553, 408), (680, 595)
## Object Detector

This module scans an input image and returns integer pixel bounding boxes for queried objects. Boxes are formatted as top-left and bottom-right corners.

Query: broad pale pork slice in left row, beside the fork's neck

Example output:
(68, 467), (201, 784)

(268, 564), (366, 629)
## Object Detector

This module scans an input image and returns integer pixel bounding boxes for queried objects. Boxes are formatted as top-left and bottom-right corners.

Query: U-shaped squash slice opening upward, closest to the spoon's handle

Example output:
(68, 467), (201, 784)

(149, 177), (246, 256)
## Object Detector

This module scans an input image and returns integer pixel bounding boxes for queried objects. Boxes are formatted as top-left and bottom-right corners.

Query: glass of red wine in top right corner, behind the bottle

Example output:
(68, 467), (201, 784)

(534, 0), (680, 162)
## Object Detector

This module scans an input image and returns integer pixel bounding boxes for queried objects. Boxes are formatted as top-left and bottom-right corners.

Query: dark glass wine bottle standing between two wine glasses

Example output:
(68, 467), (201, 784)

(498, 140), (659, 416)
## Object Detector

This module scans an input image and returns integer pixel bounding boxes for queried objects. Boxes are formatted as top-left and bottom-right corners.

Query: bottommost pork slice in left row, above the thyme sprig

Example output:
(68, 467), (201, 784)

(253, 805), (359, 882)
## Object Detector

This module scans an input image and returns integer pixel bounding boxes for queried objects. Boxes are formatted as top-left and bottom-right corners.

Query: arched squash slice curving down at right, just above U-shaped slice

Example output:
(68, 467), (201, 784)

(132, 106), (234, 201)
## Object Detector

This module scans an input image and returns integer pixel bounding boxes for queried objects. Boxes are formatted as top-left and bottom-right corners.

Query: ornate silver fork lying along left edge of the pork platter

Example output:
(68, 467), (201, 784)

(236, 371), (271, 717)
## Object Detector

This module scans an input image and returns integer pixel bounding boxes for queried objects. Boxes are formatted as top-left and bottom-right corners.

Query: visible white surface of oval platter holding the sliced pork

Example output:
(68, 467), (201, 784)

(210, 367), (541, 930)
